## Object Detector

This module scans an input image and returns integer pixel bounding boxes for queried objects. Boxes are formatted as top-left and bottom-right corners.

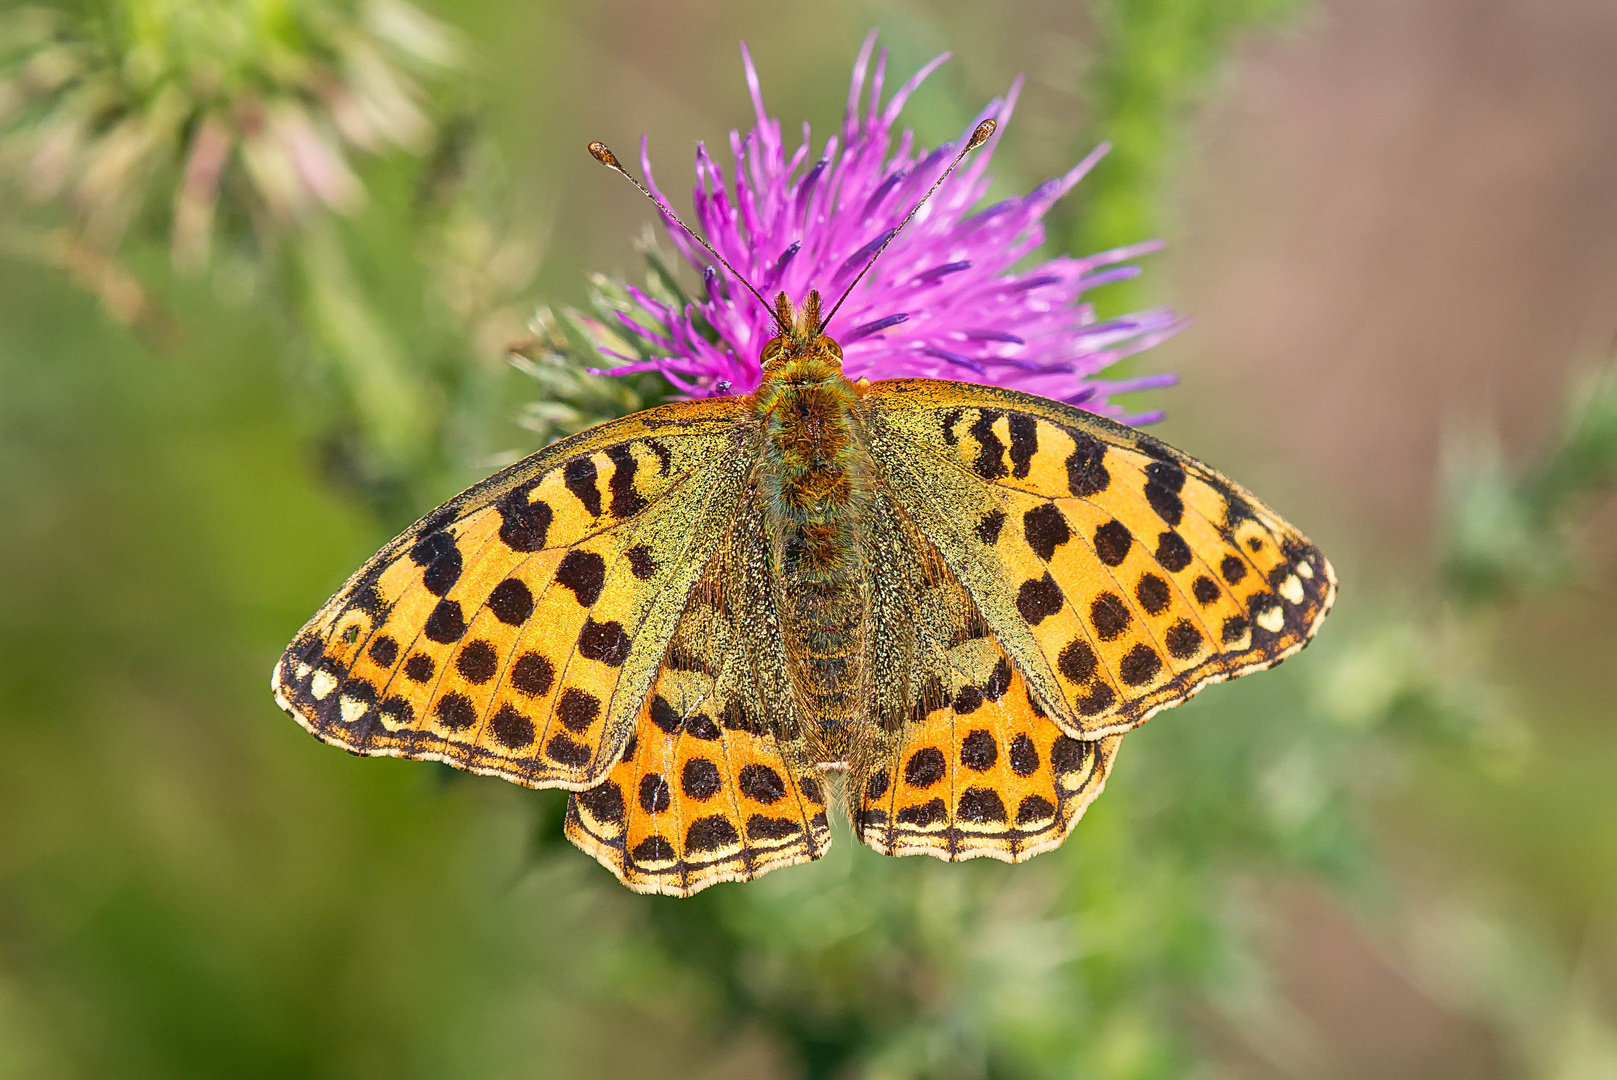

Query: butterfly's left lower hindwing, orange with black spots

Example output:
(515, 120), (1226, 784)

(566, 498), (831, 896)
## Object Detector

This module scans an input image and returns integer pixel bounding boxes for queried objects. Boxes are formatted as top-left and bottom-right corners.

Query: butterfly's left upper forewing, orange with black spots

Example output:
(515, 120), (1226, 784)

(272, 399), (755, 789)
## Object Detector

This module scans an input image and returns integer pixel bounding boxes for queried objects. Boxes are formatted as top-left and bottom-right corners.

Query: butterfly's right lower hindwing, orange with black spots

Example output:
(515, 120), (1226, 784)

(846, 493), (1122, 862)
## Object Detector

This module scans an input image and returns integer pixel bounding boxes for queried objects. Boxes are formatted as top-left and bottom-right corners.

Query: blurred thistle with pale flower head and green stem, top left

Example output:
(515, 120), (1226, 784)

(0, 0), (537, 508)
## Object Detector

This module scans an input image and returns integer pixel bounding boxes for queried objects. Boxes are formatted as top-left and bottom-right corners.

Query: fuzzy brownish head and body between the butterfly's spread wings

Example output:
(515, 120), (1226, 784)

(752, 294), (873, 761)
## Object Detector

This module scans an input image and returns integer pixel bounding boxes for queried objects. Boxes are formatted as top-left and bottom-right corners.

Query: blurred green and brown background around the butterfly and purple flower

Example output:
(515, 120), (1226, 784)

(0, 0), (1617, 1080)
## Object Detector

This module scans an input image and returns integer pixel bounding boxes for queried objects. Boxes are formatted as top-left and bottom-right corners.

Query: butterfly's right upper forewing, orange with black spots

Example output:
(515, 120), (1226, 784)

(870, 380), (1336, 739)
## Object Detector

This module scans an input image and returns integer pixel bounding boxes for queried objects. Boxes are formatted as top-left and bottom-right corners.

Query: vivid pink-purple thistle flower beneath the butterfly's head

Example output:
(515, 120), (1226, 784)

(602, 32), (1185, 424)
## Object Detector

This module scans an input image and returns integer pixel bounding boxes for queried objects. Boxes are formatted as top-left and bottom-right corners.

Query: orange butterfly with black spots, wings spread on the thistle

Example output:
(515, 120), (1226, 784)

(272, 121), (1336, 896)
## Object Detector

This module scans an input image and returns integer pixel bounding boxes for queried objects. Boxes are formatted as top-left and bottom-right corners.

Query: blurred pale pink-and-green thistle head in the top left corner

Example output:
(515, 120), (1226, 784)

(0, 0), (459, 282)
